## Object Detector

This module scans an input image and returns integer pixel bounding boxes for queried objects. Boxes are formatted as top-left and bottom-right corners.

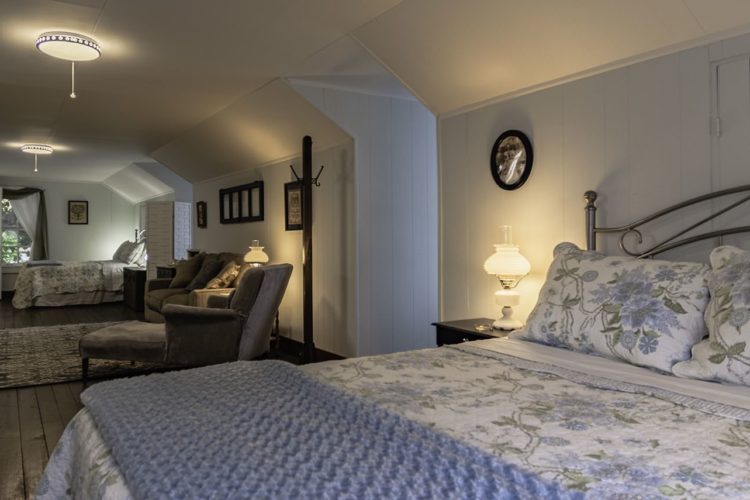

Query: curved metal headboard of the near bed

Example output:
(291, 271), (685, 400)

(583, 184), (750, 258)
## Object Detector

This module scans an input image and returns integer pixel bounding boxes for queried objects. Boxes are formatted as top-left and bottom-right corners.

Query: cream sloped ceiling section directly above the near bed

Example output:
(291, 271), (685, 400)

(354, 0), (750, 115)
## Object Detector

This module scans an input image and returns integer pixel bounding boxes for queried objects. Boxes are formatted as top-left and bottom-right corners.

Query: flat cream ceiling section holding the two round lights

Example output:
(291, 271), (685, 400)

(0, 0), (398, 181)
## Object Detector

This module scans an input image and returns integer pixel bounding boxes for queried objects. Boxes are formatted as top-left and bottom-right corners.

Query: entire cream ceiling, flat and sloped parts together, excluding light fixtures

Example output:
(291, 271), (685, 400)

(0, 0), (750, 188)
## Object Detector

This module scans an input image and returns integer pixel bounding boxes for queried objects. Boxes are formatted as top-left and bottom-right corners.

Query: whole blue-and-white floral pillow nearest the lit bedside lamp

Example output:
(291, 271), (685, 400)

(511, 243), (709, 371)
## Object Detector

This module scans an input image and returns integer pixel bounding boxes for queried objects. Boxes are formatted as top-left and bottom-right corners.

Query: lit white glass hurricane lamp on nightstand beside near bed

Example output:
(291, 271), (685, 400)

(484, 226), (531, 330)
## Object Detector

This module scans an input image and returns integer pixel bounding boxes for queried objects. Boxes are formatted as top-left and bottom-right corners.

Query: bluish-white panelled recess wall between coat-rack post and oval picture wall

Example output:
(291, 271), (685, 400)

(293, 83), (438, 355)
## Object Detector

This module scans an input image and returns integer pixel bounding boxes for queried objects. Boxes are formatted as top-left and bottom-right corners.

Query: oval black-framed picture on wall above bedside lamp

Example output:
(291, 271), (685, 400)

(490, 130), (534, 191)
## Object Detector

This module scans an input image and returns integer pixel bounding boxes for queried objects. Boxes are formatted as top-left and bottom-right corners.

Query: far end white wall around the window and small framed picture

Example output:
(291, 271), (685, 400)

(0, 177), (135, 289)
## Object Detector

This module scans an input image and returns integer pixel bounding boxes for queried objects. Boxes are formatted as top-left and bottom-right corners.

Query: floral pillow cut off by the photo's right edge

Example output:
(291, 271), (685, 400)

(672, 246), (750, 385)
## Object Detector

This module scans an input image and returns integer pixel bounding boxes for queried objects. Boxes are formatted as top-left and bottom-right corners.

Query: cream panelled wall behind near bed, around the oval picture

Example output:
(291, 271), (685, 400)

(438, 32), (750, 319)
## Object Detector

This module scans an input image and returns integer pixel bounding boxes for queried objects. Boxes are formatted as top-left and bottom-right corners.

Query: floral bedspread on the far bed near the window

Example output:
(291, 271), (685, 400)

(13, 261), (127, 309)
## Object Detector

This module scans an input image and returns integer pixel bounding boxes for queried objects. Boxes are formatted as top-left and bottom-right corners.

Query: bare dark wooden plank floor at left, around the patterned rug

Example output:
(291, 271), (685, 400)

(0, 298), (143, 500)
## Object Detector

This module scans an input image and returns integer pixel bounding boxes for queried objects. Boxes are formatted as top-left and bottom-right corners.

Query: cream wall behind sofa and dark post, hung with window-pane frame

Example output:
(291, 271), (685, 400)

(193, 143), (357, 357)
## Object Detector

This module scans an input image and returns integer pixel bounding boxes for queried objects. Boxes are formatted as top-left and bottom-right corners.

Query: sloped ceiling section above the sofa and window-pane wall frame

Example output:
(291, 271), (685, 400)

(152, 79), (350, 182)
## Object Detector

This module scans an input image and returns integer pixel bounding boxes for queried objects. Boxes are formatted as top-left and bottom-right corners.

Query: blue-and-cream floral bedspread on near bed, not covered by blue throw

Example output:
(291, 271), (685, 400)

(41, 348), (750, 498)
